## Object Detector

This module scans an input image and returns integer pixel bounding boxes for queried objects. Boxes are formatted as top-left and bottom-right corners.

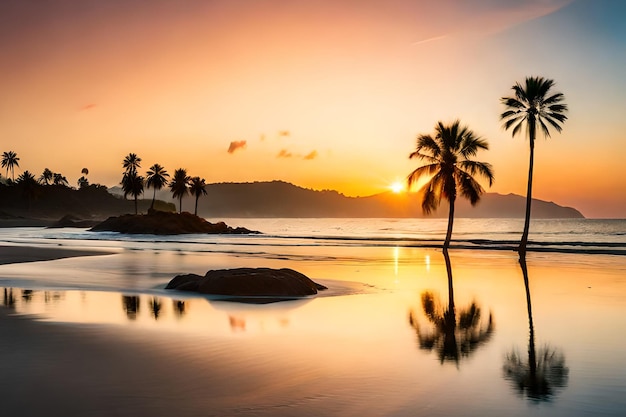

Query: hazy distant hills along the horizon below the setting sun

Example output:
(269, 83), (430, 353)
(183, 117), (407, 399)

(134, 181), (584, 219)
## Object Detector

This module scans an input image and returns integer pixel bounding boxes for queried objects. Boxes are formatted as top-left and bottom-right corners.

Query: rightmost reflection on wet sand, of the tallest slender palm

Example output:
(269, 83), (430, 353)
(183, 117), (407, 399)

(504, 256), (569, 401)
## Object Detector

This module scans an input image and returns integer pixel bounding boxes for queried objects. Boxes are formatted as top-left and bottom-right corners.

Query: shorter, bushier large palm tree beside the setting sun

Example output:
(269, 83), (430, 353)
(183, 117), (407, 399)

(408, 120), (493, 249)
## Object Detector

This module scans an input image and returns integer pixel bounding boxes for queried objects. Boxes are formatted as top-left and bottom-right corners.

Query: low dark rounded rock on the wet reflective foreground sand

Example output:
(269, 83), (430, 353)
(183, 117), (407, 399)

(165, 268), (326, 298)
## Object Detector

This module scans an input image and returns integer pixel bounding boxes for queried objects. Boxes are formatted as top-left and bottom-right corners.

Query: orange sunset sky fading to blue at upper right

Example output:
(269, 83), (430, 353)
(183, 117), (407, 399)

(0, 0), (626, 218)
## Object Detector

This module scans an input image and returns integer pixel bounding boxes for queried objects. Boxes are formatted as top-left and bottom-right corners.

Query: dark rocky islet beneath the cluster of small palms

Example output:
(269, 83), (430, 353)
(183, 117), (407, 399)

(89, 211), (259, 235)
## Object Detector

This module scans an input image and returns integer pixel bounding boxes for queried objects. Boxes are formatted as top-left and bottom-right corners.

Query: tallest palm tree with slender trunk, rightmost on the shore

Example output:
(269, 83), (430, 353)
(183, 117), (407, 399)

(500, 77), (567, 257)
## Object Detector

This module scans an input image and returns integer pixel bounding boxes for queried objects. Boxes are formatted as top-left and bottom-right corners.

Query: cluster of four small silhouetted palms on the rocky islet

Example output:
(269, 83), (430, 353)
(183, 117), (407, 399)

(121, 153), (207, 216)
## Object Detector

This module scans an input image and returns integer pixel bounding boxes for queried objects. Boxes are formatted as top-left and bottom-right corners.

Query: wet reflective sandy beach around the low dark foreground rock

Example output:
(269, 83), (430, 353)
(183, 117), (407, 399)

(0, 226), (626, 416)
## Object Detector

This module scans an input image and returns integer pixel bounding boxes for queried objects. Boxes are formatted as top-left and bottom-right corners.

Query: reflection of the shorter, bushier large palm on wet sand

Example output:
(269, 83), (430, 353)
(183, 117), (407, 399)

(409, 249), (494, 364)
